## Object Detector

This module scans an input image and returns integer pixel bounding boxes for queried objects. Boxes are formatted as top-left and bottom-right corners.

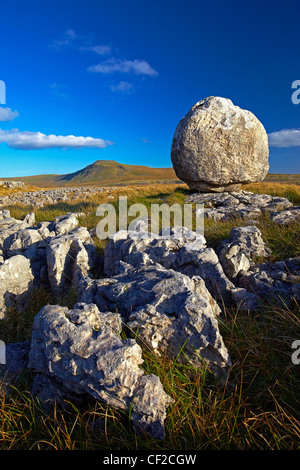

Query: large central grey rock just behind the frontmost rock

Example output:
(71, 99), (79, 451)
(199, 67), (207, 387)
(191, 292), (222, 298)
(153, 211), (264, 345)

(79, 262), (230, 375)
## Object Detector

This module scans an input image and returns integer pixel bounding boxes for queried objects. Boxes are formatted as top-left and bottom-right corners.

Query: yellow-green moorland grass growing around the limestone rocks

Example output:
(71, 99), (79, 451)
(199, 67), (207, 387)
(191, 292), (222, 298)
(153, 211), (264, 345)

(0, 183), (300, 451)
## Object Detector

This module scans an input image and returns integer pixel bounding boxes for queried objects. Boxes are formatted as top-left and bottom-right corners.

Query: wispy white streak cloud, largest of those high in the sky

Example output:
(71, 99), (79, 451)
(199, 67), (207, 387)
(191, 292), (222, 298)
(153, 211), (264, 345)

(87, 57), (158, 76)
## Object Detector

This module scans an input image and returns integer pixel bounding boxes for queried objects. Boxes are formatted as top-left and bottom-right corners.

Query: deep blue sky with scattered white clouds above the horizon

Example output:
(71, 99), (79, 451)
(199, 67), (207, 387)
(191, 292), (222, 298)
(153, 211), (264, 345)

(0, 0), (300, 177)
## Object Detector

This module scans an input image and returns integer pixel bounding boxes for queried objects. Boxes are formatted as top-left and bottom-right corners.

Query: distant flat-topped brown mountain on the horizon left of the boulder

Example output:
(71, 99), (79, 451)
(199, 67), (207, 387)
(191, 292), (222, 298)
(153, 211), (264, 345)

(2, 160), (179, 188)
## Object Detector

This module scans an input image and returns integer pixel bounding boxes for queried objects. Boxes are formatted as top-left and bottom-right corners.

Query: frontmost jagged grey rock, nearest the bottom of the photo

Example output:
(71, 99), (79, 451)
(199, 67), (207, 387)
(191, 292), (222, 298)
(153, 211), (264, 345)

(28, 303), (173, 439)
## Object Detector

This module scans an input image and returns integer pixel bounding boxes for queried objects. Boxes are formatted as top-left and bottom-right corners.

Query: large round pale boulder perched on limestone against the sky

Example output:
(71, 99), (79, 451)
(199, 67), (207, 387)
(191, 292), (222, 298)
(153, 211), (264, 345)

(171, 96), (269, 192)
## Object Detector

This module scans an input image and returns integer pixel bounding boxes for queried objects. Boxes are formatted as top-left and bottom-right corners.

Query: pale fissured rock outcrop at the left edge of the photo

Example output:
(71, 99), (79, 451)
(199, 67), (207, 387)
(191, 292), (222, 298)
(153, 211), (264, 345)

(0, 210), (100, 317)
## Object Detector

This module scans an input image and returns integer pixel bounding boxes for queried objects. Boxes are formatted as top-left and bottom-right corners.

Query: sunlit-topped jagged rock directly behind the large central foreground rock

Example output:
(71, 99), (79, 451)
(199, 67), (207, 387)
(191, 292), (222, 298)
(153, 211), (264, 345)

(104, 227), (234, 303)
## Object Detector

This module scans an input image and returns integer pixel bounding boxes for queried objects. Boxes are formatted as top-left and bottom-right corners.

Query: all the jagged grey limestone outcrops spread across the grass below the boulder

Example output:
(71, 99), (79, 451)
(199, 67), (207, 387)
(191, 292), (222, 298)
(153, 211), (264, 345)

(0, 191), (300, 438)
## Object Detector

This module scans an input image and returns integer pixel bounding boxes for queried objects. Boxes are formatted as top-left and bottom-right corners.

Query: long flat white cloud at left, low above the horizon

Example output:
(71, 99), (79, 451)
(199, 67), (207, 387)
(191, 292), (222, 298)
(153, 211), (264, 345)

(0, 129), (113, 150)
